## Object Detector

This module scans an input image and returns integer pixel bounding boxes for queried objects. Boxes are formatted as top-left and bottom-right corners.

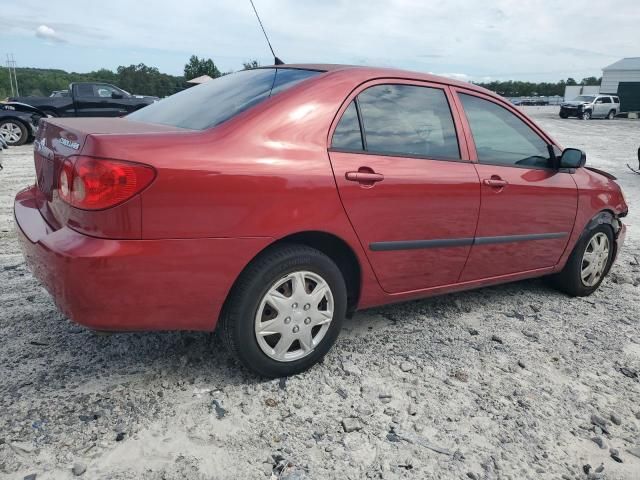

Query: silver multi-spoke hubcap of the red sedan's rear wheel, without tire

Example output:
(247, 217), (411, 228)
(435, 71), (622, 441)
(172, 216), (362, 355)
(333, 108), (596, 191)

(255, 271), (334, 362)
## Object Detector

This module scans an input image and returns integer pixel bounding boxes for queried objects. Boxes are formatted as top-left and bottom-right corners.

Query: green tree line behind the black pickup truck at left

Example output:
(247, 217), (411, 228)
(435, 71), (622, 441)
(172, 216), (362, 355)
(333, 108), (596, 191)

(0, 55), (259, 100)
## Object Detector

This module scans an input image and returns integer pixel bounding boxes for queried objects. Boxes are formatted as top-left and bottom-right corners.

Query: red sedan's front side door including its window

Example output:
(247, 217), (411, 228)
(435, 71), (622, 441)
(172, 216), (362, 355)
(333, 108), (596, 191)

(458, 91), (578, 281)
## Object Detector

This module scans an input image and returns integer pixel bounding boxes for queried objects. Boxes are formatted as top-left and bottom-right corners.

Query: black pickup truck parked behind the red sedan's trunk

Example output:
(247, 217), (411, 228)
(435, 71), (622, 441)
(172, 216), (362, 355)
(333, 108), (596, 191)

(9, 82), (158, 117)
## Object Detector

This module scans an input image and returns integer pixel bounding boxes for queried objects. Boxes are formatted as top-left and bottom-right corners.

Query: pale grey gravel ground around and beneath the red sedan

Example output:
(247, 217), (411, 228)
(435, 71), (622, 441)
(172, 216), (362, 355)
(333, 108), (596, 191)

(0, 107), (640, 480)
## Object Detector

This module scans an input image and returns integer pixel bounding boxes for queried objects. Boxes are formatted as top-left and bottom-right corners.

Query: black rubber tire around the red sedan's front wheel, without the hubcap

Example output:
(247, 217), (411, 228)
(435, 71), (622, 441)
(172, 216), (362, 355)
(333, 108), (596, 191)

(550, 224), (615, 297)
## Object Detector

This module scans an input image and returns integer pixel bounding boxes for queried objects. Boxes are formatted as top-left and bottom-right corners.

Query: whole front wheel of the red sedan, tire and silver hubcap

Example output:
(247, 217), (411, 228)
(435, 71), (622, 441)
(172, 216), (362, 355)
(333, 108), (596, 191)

(553, 225), (614, 297)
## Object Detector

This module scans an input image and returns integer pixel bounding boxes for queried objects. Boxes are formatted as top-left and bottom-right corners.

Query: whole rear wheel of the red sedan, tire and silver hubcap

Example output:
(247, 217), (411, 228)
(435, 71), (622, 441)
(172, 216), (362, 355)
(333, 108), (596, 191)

(219, 245), (347, 378)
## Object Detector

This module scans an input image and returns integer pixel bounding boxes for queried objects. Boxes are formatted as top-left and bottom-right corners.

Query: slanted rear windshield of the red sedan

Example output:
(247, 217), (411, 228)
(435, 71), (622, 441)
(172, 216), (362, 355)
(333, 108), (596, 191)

(127, 68), (322, 130)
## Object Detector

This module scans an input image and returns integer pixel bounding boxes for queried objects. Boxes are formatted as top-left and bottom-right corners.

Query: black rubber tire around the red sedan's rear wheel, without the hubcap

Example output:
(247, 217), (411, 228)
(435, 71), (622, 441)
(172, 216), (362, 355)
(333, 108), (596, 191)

(218, 244), (347, 378)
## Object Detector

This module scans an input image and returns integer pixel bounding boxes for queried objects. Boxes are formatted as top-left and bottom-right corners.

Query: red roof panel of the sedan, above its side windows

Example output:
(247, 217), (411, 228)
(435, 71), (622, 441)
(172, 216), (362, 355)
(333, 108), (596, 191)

(260, 63), (497, 96)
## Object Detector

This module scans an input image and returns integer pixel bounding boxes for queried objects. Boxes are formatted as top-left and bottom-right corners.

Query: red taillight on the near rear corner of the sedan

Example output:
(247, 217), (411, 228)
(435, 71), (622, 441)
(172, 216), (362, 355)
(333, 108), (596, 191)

(58, 157), (155, 210)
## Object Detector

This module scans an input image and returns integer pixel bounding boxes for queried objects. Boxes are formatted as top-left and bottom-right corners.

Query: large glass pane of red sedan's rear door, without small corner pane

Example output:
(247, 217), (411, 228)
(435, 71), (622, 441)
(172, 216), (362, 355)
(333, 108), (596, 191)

(358, 85), (460, 160)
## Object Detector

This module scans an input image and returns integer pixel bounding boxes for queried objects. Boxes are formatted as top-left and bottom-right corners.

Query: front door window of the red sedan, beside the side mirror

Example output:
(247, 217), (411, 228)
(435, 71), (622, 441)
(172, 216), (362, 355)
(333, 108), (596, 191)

(460, 94), (551, 168)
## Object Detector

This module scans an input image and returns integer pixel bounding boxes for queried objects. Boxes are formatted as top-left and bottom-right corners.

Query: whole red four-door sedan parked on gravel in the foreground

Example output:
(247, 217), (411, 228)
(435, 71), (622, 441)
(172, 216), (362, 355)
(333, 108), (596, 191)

(15, 65), (627, 377)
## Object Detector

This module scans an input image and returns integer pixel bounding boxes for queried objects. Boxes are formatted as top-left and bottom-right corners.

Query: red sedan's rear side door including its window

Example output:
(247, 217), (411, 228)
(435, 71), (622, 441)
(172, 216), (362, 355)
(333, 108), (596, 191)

(329, 80), (480, 293)
